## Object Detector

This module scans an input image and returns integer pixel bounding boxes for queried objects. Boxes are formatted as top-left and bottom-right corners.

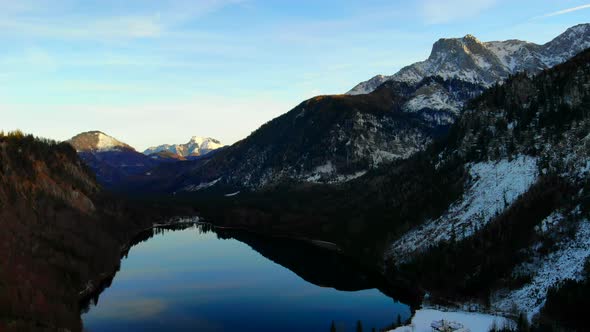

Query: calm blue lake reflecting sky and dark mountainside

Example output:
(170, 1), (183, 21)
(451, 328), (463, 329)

(82, 225), (410, 332)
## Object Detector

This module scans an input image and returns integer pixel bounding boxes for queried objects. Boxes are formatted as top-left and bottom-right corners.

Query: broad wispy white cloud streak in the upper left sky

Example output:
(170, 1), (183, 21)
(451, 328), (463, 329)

(0, 0), (246, 41)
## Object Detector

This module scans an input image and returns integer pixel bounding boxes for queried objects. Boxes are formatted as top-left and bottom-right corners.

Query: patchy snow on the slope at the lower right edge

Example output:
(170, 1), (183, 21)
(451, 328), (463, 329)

(492, 217), (590, 319)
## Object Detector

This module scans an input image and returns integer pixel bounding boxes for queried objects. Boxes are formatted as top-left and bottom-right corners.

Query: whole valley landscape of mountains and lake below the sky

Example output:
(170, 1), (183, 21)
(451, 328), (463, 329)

(0, 14), (590, 332)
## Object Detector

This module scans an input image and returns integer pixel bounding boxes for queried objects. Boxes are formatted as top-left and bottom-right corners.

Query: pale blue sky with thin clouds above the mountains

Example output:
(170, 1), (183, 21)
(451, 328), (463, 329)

(0, 0), (590, 149)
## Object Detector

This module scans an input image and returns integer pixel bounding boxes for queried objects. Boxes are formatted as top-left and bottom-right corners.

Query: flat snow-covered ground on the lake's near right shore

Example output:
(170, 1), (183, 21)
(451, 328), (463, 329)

(390, 309), (513, 332)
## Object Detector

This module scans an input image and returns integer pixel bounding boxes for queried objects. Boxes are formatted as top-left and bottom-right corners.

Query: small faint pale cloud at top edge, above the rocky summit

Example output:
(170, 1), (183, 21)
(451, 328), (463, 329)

(421, 0), (497, 24)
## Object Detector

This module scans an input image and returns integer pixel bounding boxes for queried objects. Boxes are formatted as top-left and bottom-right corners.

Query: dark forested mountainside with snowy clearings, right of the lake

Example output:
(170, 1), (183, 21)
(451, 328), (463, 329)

(203, 49), (590, 331)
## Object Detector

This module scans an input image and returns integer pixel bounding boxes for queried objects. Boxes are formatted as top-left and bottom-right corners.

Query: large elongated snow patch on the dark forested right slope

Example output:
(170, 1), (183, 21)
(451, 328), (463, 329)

(386, 155), (538, 262)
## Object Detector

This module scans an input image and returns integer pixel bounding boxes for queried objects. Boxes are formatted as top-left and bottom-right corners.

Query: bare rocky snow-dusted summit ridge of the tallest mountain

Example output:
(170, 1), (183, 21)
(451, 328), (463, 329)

(347, 24), (590, 95)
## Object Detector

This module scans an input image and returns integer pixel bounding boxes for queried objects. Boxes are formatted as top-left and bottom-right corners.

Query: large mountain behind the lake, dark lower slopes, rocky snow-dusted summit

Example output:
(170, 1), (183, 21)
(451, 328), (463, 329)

(135, 25), (590, 192)
